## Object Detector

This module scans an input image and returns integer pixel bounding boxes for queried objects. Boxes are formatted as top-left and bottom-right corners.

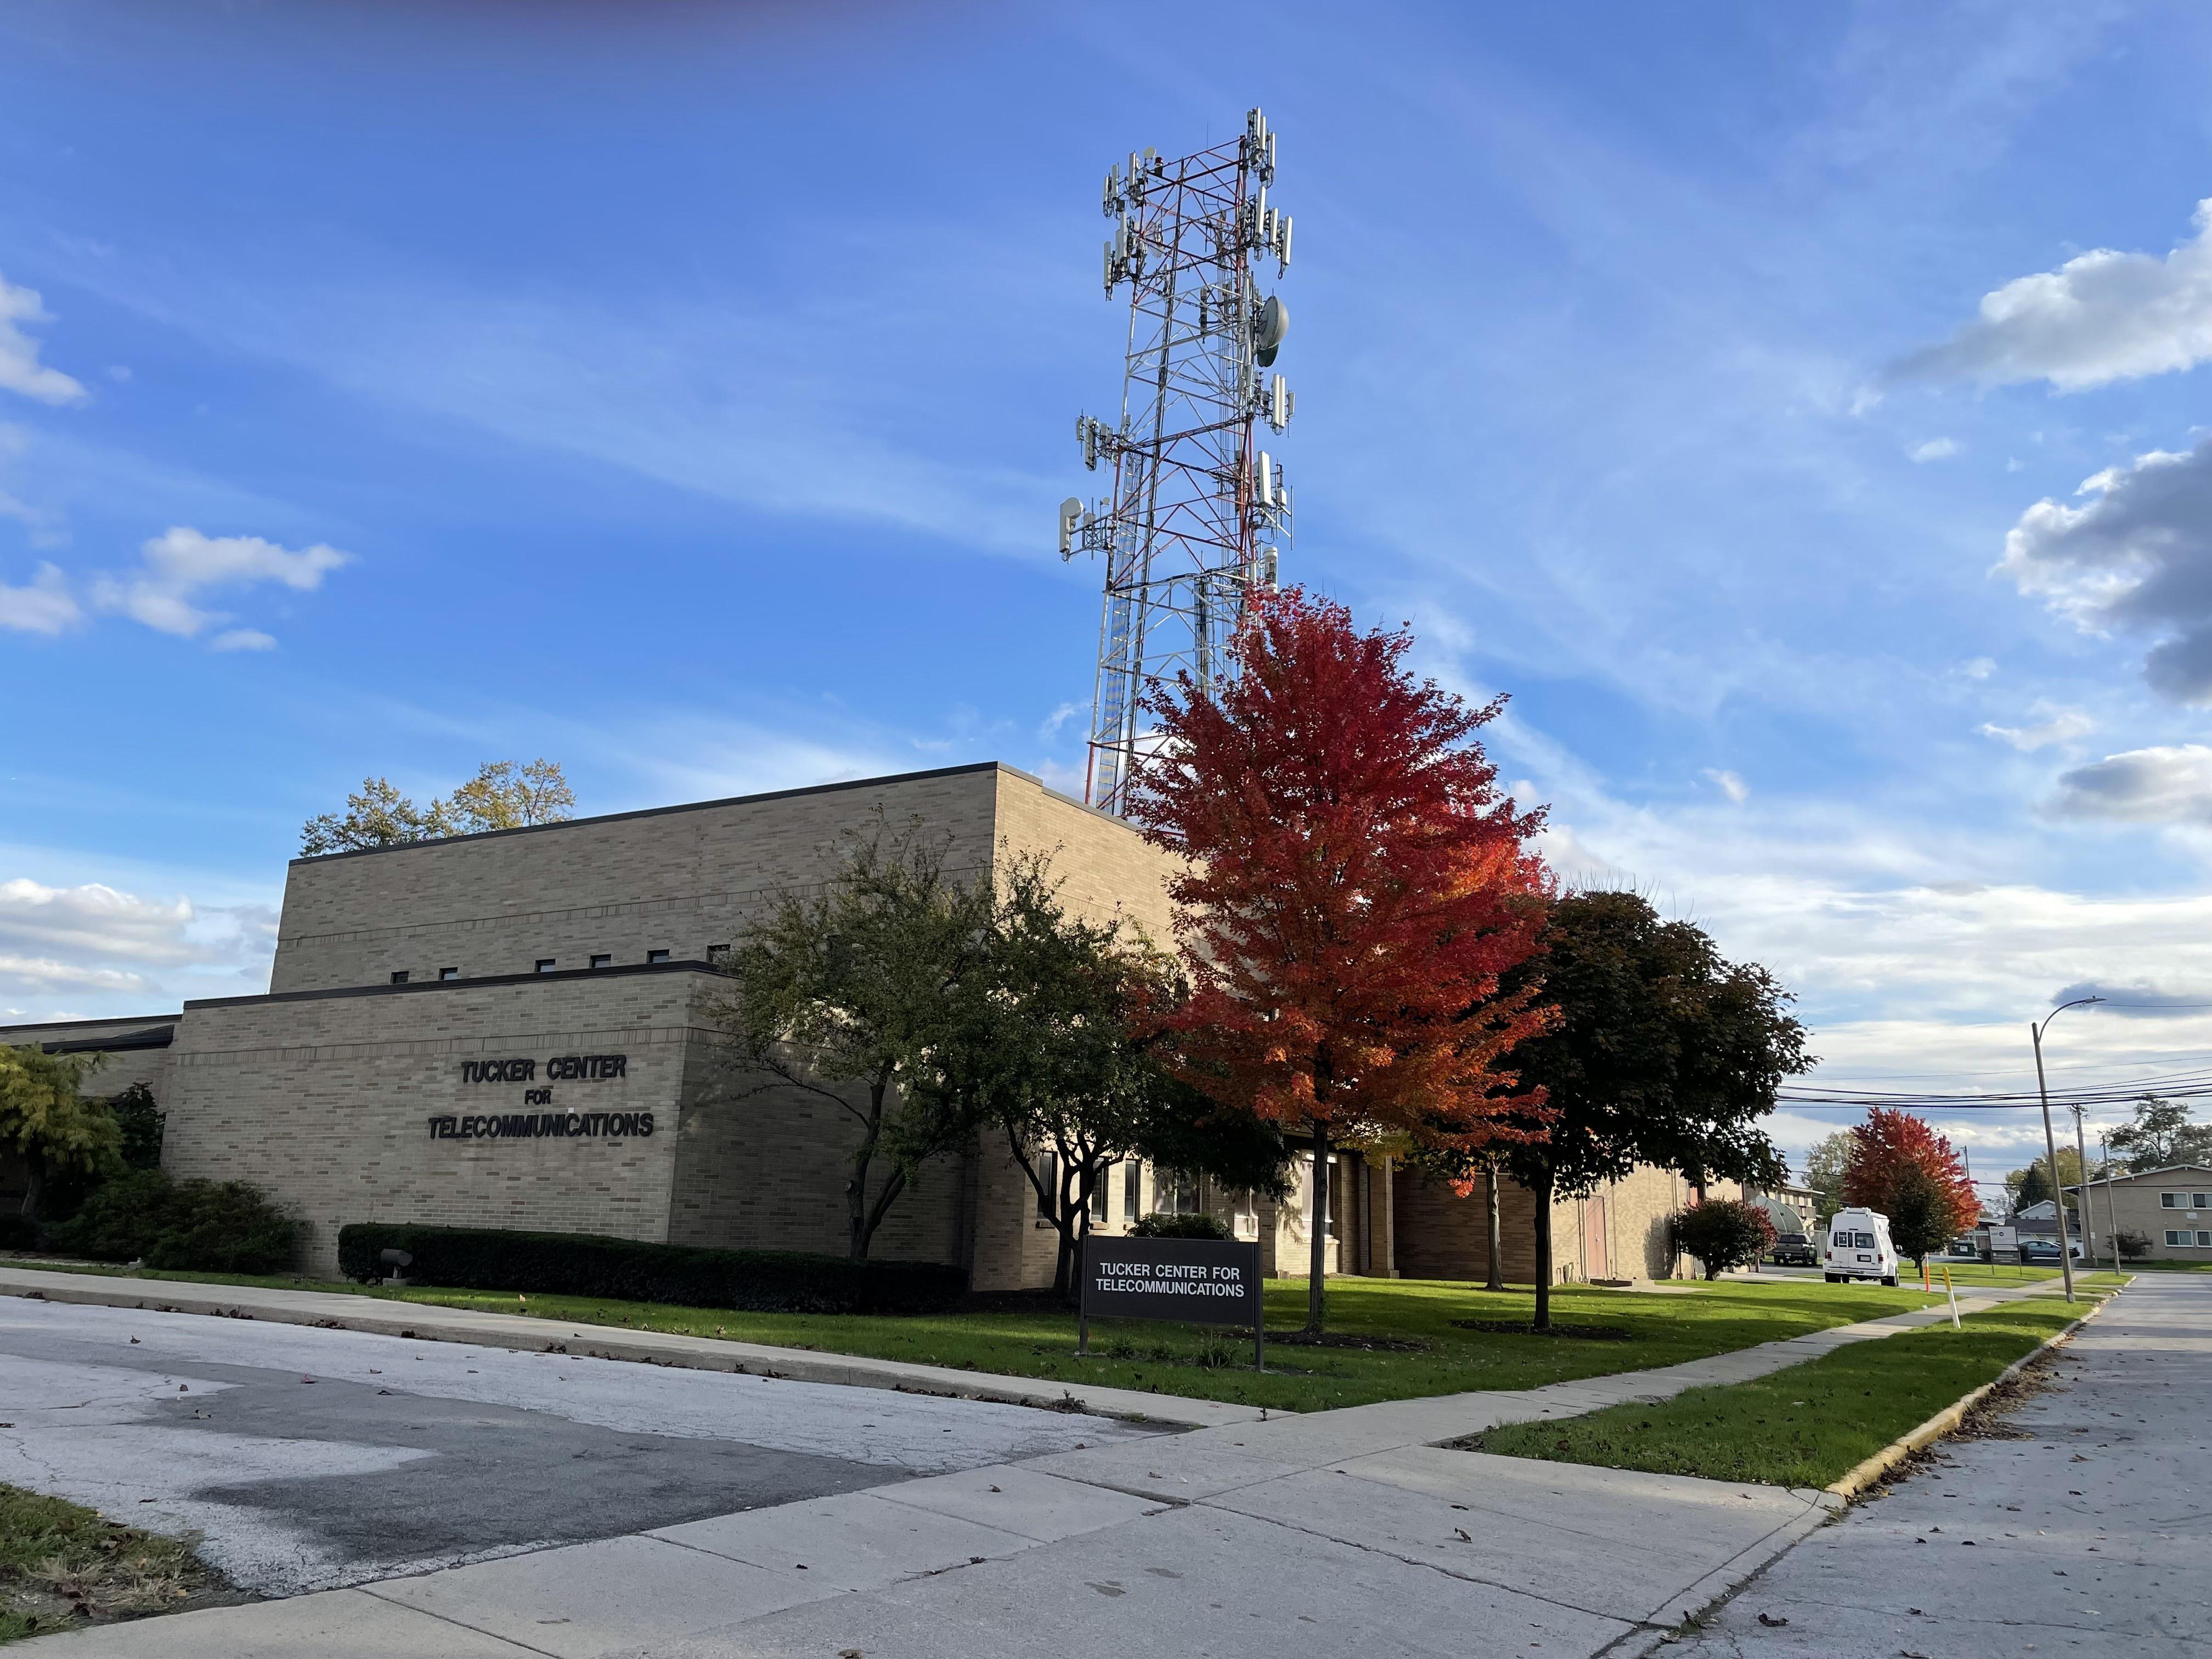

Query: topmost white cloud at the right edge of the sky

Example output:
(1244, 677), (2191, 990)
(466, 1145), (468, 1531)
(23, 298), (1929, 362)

(1891, 199), (2212, 392)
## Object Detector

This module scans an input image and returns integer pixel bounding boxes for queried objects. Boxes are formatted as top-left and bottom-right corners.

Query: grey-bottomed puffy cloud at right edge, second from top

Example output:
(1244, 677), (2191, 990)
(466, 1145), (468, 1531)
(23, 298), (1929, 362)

(1997, 438), (2212, 703)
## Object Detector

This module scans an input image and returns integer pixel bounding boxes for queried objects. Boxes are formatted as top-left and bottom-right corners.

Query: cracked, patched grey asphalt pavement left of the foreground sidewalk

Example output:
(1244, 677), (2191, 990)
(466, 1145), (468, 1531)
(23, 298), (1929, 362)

(0, 1296), (1144, 1595)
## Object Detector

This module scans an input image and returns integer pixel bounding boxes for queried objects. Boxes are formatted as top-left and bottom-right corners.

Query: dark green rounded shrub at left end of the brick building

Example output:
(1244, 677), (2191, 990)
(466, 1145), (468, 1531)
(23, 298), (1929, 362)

(47, 1170), (298, 1274)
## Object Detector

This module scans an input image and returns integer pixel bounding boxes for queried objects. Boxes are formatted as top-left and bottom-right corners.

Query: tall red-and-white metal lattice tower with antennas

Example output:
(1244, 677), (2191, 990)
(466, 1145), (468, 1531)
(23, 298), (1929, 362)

(1059, 111), (1292, 814)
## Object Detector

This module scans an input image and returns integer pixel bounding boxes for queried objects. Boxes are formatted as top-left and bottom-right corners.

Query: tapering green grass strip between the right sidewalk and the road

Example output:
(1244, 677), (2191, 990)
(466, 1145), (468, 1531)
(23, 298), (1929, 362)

(1460, 1296), (2084, 1487)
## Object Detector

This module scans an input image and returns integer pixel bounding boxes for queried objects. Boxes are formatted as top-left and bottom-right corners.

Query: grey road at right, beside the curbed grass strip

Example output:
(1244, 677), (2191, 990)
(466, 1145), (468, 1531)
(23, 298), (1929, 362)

(1666, 1274), (2212, 1659)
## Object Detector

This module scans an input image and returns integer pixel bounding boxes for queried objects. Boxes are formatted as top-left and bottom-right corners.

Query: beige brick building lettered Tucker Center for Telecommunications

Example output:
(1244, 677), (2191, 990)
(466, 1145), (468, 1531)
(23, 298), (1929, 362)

(0, 763), (1681, 1290)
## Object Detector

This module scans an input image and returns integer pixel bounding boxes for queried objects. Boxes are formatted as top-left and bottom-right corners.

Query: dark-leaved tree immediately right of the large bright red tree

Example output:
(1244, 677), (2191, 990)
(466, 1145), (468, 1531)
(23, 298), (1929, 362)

(1466, 891), (1812, 1329)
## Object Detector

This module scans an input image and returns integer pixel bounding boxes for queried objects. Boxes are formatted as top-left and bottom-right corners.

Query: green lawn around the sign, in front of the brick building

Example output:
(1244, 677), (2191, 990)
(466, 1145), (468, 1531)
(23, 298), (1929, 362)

(0, 1263), (2097, 1411)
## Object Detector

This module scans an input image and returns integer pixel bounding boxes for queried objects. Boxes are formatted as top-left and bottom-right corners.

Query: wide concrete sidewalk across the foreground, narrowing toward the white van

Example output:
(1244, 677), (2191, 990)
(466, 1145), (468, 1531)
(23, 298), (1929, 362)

(13, 1281), (2088, 1659)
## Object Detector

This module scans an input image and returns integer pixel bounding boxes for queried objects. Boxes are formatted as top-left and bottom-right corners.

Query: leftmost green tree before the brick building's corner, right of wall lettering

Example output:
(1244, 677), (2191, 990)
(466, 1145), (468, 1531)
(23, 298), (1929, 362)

(714, 814), (993, 1261)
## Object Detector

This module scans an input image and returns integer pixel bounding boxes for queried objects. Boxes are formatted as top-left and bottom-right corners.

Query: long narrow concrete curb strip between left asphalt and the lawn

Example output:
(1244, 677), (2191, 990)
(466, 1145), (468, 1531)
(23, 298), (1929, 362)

(0, 1265), (1281, 1429)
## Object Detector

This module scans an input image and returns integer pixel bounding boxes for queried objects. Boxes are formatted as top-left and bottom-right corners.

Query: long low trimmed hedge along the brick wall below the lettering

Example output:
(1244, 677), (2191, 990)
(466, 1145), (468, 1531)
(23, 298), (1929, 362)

(338, 1221), (967, 1314)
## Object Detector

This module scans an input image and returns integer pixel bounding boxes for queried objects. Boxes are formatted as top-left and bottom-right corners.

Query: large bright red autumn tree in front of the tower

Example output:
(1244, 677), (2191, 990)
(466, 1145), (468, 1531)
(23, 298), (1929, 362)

(1128, 589), (1553, 1331)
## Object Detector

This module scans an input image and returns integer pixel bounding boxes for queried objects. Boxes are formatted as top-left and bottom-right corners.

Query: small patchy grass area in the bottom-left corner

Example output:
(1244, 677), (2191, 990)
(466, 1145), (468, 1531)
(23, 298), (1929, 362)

(0, 1487), (208, 1641)
